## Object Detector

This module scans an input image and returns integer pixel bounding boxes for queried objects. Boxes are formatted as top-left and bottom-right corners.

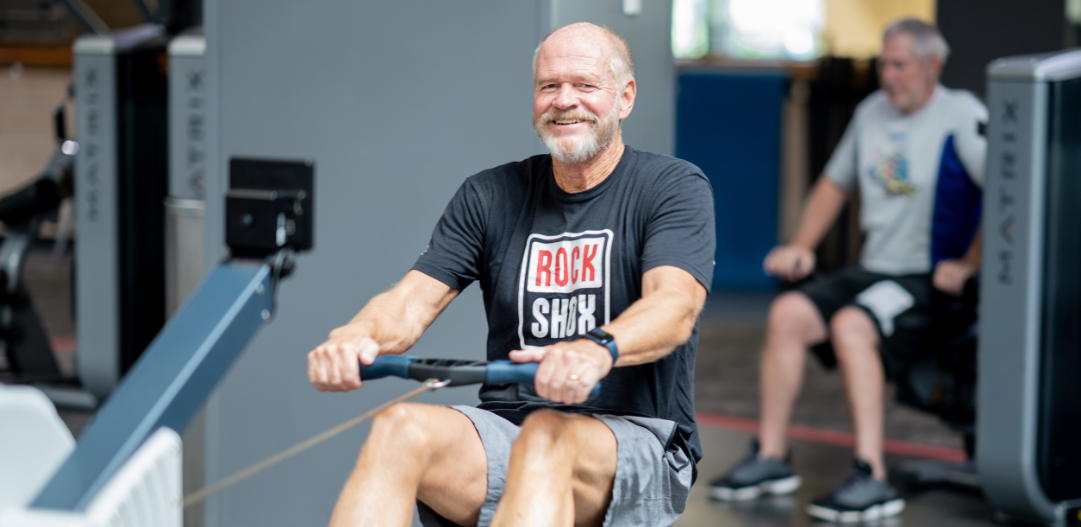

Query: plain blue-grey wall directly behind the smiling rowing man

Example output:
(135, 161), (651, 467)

(197, 0), (675, 527)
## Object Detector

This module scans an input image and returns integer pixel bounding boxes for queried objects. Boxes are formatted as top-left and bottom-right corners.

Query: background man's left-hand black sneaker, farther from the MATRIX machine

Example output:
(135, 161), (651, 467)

(709, 441), (801, 501)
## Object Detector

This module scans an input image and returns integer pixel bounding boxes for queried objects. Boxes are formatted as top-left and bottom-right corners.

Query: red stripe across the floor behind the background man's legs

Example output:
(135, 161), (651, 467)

(695, 411), (966, 462)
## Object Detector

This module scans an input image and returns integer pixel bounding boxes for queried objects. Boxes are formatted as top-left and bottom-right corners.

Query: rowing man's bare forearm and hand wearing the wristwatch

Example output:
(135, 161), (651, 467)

(510, 266), (706, 403)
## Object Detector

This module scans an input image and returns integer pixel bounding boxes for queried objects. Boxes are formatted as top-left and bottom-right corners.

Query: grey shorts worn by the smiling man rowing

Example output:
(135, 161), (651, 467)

(417, 406), (694, 527)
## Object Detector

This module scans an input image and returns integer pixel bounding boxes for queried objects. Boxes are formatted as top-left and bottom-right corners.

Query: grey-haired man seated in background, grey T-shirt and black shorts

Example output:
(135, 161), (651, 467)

(711, 19), (987, 521)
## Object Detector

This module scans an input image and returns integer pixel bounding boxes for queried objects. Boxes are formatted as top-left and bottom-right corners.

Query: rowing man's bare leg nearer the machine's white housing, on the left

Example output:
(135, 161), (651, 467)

(331, 404), (488, 527)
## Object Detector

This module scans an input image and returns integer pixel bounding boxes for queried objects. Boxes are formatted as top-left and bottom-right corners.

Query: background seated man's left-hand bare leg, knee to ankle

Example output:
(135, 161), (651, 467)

(758, 292), (827, 459)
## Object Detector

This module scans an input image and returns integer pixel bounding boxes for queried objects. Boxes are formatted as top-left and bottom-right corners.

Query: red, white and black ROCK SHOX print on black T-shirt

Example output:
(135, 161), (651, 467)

(518, 229), (612, 349)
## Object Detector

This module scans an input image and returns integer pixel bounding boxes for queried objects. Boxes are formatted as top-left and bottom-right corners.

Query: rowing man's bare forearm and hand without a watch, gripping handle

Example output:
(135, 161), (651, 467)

(308, 271), (458, 392)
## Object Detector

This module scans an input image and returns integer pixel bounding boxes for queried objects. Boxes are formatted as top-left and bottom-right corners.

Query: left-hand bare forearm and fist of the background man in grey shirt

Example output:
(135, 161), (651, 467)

(762, 174), (849, 281)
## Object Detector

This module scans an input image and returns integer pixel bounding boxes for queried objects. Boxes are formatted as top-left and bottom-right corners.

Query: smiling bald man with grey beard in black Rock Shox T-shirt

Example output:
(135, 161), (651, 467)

(308, 24), (715, 527)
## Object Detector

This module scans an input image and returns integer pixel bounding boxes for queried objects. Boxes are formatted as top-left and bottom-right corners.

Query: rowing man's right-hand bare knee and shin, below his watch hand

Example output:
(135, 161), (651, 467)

(492, 410), (616, 527)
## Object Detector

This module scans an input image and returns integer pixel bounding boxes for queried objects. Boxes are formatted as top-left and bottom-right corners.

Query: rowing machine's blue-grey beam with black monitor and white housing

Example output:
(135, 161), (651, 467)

(0, 159), (315, 527)
